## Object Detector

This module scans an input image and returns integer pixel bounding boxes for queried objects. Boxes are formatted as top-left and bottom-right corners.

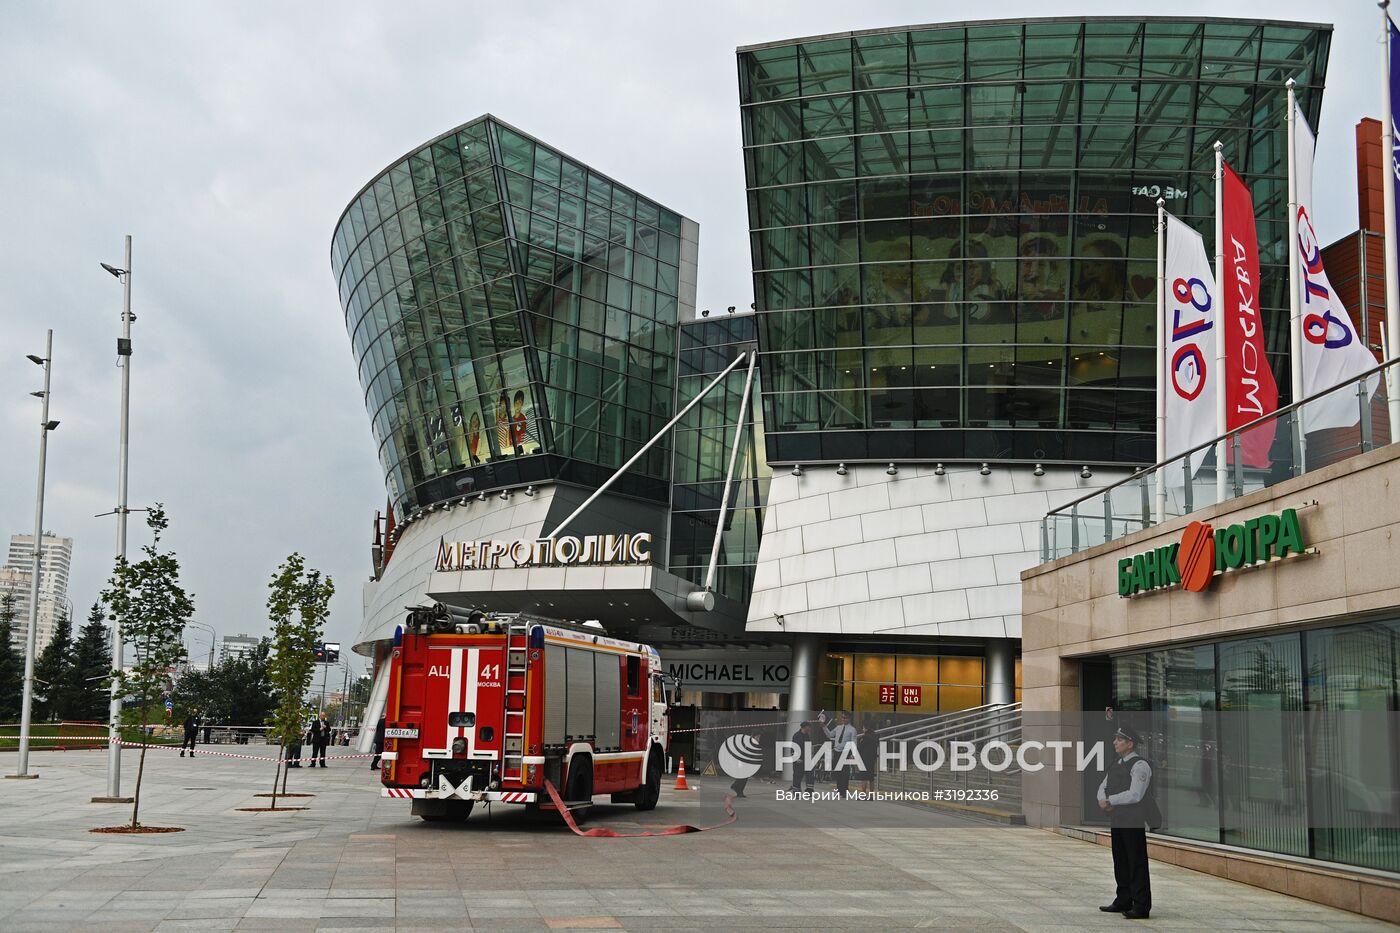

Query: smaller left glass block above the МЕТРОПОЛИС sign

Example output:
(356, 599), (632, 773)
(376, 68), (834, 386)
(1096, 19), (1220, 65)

(330, 116), (697, 516)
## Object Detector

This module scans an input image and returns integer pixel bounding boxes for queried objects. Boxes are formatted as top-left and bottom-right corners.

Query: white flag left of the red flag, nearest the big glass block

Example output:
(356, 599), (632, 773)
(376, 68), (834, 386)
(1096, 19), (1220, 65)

(1158, 214), (1219, 486)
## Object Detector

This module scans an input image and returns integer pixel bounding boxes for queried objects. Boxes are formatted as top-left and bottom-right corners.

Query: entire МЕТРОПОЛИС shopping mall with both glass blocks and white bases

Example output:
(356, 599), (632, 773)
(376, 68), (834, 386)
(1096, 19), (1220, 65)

(330, 17), (1330, 734)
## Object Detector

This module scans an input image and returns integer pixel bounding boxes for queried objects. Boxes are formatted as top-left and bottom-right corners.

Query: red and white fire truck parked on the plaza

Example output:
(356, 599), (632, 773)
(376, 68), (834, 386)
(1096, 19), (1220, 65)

(381, 604), (668, 821)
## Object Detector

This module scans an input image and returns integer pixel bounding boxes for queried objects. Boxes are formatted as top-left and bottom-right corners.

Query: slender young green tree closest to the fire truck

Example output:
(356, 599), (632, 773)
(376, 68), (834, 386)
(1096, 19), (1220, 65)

(267, 552), (336, 810)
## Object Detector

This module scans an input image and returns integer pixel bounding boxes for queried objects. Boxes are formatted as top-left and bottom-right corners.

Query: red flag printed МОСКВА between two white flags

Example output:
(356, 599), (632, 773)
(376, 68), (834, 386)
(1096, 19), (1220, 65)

(1219, 164), (1278, 467)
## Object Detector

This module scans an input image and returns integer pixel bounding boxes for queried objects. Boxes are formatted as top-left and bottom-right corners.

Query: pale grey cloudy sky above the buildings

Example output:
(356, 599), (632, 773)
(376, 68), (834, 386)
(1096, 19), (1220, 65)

(0, 0), (1380, 664)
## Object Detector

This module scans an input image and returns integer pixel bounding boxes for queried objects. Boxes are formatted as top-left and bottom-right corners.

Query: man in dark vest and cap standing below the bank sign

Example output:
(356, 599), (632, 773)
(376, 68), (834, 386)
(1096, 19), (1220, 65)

(1098, 723), (1162, 920)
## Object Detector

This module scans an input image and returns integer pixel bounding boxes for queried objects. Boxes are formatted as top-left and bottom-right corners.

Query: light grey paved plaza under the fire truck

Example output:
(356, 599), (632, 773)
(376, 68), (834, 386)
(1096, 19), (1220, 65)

(0, 747), (1387, 933)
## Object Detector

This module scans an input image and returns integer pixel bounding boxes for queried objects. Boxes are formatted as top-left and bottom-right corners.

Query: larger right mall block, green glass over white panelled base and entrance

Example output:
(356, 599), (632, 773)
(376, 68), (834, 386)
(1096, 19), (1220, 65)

(738, 17), (1331, 712)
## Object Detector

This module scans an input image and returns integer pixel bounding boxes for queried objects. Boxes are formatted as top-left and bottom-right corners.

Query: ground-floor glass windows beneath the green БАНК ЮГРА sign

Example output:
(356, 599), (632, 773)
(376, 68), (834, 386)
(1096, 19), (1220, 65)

(1112, 619), (1400, 871)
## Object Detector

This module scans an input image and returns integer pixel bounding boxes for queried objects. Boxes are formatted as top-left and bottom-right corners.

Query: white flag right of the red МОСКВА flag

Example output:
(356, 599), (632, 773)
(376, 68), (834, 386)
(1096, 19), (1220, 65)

(1294, 113), (1379, 434)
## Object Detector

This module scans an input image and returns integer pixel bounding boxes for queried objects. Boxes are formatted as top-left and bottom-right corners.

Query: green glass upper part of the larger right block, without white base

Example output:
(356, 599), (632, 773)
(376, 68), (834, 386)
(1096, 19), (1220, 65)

(739, 18), (1331, 473)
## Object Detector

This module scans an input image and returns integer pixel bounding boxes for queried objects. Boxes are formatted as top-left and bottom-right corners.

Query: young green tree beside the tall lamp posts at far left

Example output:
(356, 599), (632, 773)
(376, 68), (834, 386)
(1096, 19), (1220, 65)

(102, 503), (195, 829)
